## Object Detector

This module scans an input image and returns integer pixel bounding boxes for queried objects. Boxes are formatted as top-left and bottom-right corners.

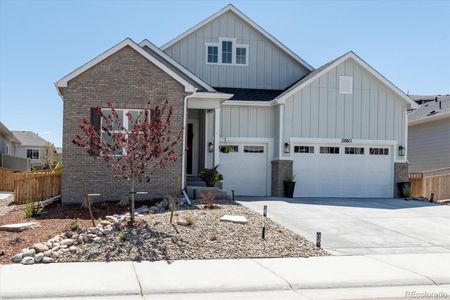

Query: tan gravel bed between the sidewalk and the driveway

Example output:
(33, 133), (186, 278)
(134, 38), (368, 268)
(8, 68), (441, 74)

(57, 203), (329, 262)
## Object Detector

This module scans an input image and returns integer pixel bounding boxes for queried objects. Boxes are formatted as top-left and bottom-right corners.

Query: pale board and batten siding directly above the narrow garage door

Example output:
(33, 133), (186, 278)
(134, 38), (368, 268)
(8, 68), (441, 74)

(220, 105), (275, 138)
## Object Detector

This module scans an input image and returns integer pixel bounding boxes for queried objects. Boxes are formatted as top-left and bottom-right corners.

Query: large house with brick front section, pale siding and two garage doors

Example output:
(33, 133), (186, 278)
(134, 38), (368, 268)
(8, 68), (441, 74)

(56, 5), (417, 203)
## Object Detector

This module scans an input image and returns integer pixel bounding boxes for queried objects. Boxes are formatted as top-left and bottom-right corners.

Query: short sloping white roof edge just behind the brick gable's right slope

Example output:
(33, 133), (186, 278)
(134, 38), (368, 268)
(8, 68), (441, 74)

(139, 39), (214, 92)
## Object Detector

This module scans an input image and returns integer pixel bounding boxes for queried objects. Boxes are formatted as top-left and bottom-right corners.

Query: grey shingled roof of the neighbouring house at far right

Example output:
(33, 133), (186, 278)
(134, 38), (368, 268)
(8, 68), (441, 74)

(408, 95), (450, 125)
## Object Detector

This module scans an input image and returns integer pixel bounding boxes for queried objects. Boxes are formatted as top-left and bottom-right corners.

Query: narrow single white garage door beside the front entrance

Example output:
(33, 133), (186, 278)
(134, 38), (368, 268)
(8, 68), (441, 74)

(219, 143), (270, 196)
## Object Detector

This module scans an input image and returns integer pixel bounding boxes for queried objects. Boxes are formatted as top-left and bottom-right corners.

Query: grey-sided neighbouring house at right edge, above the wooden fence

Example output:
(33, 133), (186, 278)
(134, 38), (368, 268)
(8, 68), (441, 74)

(408, 95), (450, 172)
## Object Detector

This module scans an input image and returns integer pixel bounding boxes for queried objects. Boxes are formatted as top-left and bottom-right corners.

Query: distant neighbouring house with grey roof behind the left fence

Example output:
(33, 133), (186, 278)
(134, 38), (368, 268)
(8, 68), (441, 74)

(12, 130), (54, 168)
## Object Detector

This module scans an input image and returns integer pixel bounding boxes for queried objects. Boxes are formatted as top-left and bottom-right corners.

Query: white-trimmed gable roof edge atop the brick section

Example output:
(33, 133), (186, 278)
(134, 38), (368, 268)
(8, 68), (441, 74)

(55, 38), (195, 92)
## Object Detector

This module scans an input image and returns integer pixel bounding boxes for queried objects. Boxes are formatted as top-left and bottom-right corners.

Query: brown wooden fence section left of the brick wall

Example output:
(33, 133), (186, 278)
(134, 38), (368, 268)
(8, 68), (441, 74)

(14, 169), (61, 204)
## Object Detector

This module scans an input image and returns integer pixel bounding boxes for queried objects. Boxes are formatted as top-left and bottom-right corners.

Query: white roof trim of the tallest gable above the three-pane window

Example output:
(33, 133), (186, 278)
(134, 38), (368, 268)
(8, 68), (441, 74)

(161, 4), (314, 71)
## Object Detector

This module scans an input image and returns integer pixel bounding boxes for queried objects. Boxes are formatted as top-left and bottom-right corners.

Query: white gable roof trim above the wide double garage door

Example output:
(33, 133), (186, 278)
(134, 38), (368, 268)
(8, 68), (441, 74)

(275, 51), (419, 109)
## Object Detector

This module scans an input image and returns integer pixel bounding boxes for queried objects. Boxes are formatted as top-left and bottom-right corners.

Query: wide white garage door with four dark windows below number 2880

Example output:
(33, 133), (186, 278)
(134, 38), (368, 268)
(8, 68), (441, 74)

(292, 143), (393, 198)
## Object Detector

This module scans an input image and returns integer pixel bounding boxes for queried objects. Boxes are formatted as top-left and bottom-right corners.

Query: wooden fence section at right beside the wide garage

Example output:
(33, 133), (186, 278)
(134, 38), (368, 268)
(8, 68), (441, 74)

(409, 168), (450, 200)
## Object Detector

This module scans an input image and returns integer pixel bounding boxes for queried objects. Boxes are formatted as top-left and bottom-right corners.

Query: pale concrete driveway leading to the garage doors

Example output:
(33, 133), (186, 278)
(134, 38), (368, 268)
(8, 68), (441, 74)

(238, 197), (450, 255)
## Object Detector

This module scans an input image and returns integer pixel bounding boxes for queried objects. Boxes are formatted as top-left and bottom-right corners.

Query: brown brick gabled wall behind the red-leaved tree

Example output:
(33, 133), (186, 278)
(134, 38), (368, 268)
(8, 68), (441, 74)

(62, 46), (186, 203)
